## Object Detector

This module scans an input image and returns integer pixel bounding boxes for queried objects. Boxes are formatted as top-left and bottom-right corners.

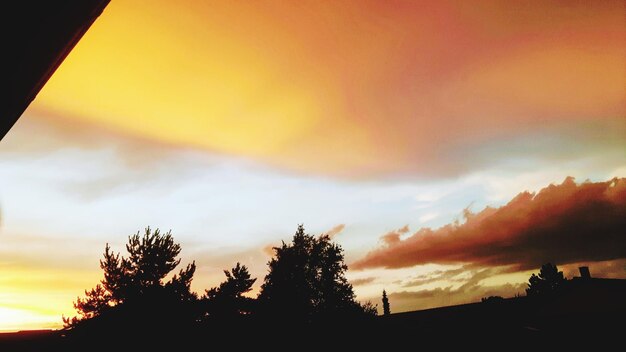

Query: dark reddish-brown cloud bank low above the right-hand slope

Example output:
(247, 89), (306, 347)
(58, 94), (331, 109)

(351, 177), (626, 270)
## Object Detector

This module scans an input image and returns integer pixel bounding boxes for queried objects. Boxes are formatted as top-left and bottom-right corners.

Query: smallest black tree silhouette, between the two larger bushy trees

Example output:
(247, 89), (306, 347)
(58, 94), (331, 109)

(203, 263), (256, 319)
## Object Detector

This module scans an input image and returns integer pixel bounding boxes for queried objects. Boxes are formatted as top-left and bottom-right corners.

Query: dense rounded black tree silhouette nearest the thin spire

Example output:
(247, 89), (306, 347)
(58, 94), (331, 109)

(259, 225), (375, 322)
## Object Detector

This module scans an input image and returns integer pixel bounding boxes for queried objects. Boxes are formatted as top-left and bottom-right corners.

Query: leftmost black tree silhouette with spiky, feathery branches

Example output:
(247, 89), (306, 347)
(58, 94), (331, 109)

(63, 227), (196, 327)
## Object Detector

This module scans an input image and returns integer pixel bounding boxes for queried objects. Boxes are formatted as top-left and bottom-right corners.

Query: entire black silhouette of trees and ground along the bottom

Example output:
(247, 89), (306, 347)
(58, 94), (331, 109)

(0, 225), (626, 352)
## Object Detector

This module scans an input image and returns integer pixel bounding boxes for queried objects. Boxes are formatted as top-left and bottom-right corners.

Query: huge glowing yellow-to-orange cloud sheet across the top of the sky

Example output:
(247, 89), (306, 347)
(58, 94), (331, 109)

(33, 1), (626, 178)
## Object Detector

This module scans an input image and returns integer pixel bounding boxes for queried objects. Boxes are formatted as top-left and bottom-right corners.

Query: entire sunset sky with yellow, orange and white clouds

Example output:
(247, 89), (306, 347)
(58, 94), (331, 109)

(0, 0), (626, 331)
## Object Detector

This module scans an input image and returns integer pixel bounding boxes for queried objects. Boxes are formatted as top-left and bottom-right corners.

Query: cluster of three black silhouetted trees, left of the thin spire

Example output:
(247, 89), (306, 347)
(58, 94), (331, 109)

(63, 225), (376, 343)
